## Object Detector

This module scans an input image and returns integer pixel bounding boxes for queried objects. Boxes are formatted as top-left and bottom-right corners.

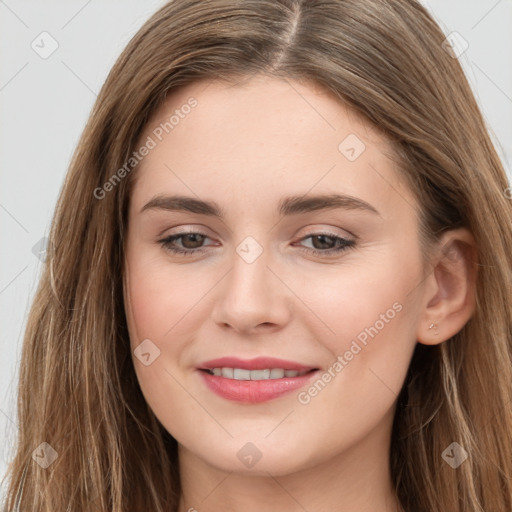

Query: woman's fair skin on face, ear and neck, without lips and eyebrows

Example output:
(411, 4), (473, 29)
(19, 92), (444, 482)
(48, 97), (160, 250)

(125, 76), (474, 512)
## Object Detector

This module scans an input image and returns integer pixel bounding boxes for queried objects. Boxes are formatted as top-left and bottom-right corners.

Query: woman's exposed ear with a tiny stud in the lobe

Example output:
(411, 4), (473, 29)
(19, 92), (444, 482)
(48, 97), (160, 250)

(416, 228), (478, 345)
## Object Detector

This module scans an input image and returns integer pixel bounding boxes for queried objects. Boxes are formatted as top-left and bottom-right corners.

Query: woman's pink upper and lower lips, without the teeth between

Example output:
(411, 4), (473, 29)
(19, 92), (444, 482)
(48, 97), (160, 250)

(198, 357), (316, 403)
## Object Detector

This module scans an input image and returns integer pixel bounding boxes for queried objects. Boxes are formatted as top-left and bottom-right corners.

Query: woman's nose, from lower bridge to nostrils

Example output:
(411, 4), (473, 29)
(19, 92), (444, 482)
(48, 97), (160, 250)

(212, 251), (292, 334)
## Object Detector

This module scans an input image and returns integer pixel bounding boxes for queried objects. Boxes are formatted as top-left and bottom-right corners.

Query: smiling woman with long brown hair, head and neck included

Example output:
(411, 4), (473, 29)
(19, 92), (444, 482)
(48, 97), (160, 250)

(1, 0), (512, 512)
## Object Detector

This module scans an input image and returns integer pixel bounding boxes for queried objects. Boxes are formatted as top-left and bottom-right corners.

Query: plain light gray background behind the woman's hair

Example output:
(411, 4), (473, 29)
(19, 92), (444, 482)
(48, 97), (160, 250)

(0, 0), (512, 494)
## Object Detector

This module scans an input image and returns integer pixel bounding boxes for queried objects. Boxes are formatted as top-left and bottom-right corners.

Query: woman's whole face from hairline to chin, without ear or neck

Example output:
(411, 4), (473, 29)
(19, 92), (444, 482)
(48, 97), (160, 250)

(125, 77), (432, 475)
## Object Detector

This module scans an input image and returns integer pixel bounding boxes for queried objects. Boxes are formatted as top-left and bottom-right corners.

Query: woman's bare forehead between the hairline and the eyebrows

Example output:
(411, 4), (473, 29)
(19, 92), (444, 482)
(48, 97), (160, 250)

(130, 76), (414, 218)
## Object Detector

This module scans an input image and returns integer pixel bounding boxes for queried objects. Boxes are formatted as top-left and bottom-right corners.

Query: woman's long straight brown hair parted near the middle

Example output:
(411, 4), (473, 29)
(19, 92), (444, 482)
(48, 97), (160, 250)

(2, 0), (512, 512)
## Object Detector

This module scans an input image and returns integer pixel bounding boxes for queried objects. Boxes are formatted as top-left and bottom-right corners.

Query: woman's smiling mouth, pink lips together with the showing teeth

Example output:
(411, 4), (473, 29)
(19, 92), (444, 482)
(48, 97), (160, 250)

(198, 357), (318, 403)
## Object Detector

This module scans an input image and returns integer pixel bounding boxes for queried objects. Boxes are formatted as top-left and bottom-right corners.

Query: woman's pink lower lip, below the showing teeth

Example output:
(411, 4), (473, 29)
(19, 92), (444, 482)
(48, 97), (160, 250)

(199, 370), (317, 404)
